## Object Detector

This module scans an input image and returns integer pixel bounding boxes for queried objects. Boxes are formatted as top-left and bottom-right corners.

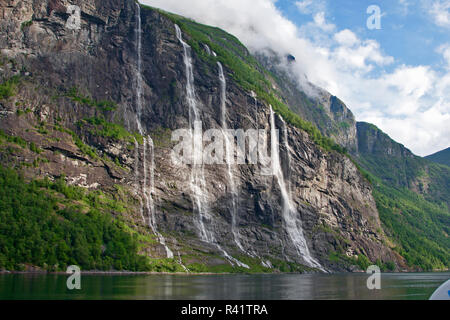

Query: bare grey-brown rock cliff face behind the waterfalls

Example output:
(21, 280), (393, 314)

(0, 0), (403, 271)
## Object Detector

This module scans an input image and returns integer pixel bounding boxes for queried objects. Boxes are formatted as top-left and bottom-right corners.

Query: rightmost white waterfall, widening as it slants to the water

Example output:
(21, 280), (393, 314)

(270, 107), (323, 270)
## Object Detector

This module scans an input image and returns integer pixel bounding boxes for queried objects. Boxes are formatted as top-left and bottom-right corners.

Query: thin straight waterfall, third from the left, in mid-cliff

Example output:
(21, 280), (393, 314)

(217, 62), (245, 252)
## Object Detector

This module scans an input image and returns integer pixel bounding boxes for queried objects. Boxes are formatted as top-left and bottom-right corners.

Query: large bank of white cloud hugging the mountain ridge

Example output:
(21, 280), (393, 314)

(143, 0), (450, 155)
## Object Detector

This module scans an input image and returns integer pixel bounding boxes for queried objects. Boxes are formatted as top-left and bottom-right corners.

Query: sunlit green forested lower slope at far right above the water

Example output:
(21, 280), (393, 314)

(374, 183), (450, 271)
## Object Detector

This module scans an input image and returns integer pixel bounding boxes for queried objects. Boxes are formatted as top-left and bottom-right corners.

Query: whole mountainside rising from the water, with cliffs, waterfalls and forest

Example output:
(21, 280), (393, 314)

(0, 0), (450, 272)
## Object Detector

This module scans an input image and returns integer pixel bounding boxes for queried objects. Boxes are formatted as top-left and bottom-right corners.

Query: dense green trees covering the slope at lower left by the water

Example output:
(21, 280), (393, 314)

(0, 166), (150, 271)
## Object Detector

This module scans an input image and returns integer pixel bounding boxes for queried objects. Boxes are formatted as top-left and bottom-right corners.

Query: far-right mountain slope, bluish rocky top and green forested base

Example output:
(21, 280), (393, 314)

(357, 123), (450, 270)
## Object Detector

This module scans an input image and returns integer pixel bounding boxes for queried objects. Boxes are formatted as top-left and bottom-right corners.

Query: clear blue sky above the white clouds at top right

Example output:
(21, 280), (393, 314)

(276, 0), (450, 68)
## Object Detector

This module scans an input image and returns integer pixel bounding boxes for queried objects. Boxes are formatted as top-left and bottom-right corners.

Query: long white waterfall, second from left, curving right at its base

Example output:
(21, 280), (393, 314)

(175, 24), (249, 268)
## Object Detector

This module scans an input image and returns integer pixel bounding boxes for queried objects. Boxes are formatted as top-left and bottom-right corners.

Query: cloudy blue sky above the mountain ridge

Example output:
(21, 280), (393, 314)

(141, 0), (450, 156)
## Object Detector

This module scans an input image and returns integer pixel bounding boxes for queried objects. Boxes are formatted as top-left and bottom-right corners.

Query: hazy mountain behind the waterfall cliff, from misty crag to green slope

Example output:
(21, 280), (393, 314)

(256, 50), (450, 270)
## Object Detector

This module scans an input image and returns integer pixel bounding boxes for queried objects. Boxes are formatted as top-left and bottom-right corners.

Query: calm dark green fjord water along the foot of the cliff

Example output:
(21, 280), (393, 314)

(0, 273), (450, 300)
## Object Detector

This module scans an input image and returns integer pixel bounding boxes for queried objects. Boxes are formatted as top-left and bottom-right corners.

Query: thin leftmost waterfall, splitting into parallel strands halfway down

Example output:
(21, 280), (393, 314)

(135, 3), (173, 258)
